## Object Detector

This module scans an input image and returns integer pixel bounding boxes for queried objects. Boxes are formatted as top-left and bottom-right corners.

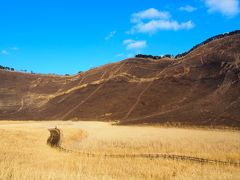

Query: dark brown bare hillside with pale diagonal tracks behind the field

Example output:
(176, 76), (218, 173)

(0, 31), (240, 127)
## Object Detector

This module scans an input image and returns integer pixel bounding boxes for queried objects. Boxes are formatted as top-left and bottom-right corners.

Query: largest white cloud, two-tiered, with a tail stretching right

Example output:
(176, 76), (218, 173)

(127, 8), (195, 34)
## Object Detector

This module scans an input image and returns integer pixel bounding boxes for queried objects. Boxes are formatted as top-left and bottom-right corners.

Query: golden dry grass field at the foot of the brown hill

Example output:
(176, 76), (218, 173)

(0, 121), (240, 180)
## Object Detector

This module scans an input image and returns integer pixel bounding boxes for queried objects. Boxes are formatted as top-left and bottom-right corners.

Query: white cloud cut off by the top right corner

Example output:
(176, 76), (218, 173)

(204, 0), (239, 17)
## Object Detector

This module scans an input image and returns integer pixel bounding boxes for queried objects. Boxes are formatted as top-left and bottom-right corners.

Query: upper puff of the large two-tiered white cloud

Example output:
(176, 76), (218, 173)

(131, 8), (171, 23)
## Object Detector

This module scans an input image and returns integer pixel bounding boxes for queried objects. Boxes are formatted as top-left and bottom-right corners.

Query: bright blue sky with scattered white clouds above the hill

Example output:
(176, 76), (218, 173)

(0, 0), (240, 74)
